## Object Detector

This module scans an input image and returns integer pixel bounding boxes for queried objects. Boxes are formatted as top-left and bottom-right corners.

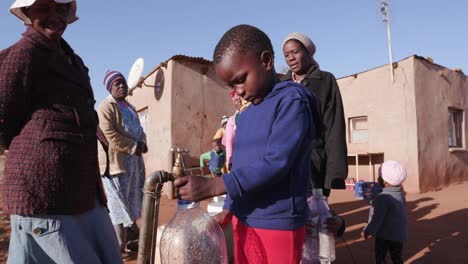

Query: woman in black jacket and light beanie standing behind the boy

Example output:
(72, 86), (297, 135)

(283, 33), (348, 196)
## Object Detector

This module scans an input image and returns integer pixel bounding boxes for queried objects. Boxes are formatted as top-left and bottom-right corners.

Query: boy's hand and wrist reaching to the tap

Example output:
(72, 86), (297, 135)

(174, 176), (226, 201)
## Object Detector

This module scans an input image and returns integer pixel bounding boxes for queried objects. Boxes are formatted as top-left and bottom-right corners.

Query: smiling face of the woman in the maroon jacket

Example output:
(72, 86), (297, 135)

(23, 0), (71, 40)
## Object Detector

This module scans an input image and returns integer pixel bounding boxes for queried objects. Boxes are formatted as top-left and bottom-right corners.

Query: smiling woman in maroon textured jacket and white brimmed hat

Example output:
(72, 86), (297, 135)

(0, 0), (122, 263)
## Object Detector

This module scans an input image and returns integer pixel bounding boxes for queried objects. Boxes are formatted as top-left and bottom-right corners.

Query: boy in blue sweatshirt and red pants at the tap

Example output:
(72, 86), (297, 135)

(174, 25), (316, 264)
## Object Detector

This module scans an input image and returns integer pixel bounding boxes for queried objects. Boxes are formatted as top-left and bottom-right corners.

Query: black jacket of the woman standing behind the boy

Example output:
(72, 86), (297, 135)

(283, 65), (348, 189)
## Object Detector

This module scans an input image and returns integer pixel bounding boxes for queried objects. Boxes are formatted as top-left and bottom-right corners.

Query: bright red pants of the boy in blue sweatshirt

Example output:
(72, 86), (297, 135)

(232, 217), (305, 264)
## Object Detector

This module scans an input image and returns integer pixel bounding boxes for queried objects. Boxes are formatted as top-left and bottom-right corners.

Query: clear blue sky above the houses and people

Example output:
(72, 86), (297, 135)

(0, 0), (468, 103)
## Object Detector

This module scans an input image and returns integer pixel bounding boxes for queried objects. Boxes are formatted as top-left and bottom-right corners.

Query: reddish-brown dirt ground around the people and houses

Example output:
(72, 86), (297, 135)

(0, 156), (468, 264)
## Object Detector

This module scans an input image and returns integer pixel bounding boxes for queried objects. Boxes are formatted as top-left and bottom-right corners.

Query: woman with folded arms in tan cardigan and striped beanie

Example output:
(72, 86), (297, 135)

(98, 71), (148, 252)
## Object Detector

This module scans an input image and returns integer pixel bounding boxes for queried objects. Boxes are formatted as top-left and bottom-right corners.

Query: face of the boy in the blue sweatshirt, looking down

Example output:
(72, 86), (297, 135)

(215, 49), (273, 105)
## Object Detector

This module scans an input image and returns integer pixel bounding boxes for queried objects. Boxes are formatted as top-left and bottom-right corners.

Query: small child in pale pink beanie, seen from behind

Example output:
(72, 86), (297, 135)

(362, 161), (408, 264)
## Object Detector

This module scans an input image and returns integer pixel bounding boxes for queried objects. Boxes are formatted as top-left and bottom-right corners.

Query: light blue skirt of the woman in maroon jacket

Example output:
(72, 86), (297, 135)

(7, 201), (123, 264)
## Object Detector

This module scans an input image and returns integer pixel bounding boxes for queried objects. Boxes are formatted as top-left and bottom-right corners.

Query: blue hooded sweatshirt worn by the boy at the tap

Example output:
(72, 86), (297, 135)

(223, 81), (317, 230)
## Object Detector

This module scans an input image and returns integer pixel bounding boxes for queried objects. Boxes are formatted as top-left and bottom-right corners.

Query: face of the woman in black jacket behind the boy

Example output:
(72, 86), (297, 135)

(283, 39), (312, 75)
